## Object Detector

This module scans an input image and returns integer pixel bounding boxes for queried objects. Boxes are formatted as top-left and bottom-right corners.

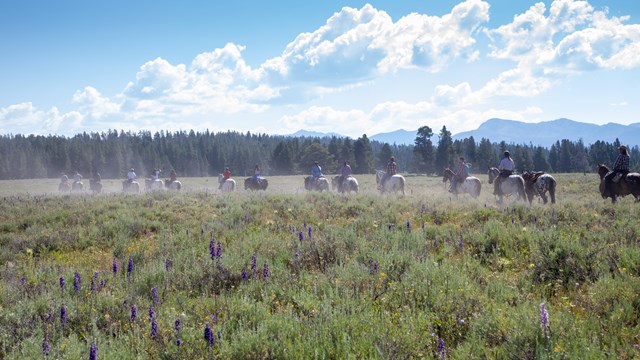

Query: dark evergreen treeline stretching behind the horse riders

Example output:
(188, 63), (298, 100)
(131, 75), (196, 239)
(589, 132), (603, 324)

(0, 126), (640, 180)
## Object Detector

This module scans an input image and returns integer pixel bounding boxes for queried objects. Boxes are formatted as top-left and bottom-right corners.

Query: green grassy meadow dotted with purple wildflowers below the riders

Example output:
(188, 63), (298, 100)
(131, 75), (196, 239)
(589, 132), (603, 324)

(0, 174), (640, 359)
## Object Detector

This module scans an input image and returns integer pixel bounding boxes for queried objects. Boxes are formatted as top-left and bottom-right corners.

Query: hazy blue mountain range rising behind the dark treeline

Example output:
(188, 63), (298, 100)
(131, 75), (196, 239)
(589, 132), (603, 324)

(291, 119), (640, 147)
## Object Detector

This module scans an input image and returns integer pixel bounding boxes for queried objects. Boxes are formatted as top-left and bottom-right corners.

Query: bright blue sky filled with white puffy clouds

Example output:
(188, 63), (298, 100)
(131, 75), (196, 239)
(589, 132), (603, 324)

(0, 0), (640, 141)
